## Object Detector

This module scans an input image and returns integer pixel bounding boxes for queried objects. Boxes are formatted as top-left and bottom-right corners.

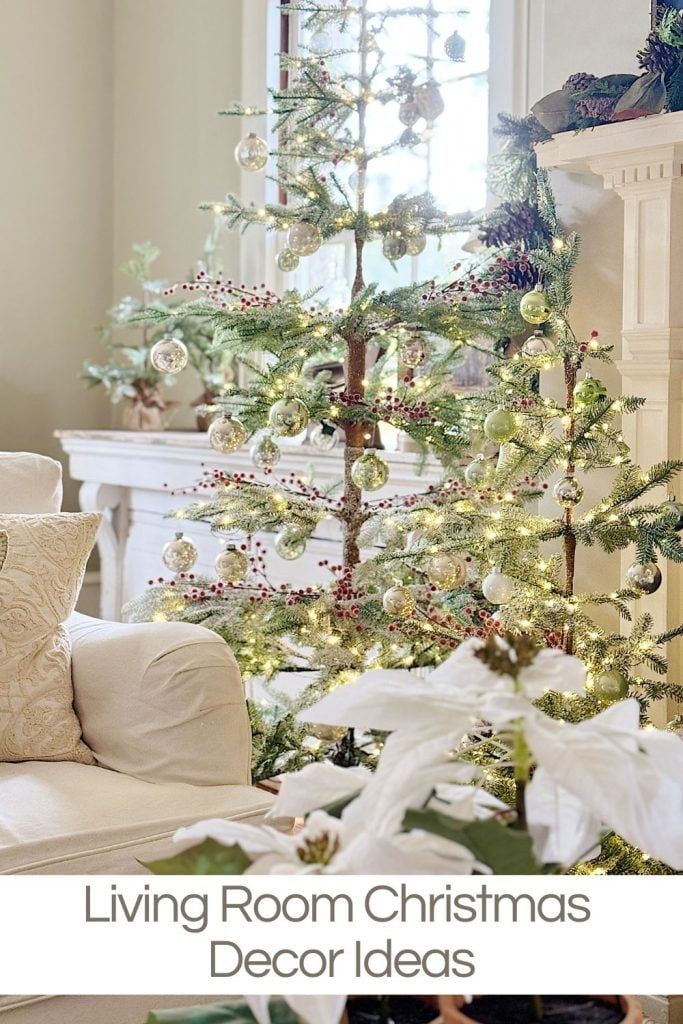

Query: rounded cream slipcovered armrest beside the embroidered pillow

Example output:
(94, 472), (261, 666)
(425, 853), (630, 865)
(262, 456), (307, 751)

(67, 613), (251, 785)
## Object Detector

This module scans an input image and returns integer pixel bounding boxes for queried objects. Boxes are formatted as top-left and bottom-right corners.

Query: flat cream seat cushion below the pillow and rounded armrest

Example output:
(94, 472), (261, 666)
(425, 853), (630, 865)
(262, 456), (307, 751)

(0, 761), (272, 874)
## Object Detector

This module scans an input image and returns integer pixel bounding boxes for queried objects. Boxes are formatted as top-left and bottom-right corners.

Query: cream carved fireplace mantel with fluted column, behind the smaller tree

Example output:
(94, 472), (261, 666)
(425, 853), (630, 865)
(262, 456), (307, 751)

(538, 113), (683, 724)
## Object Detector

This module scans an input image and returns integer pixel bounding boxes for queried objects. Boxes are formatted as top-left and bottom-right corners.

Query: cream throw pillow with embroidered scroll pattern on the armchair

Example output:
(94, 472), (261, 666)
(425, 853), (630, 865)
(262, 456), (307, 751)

(0, 512), (101, 764)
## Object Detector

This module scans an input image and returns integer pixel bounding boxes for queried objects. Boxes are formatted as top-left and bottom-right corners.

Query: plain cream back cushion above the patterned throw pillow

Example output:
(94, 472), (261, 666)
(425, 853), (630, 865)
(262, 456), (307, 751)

(0, 452), (61, 512)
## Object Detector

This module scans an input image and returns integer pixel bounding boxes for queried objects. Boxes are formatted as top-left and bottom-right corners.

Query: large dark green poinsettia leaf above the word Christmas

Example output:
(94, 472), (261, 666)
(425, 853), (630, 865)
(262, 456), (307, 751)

(403, 809), (544, 874)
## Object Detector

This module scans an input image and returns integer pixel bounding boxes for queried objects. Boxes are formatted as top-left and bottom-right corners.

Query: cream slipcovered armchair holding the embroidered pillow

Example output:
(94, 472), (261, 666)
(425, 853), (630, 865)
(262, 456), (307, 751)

(0, 453), (271, 873)
